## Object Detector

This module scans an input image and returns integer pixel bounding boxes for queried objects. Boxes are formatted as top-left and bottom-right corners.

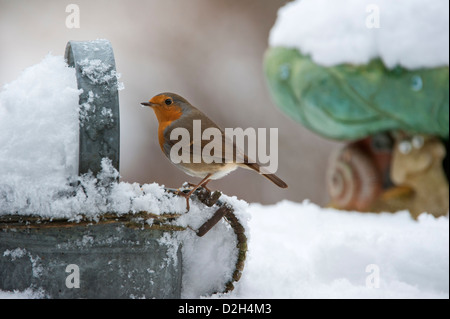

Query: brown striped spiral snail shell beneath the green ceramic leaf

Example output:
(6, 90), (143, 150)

(327, 143), (382, 211)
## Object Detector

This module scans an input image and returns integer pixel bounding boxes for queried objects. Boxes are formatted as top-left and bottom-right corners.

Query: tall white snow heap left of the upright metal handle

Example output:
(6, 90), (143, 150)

(0, 55), (80, 218)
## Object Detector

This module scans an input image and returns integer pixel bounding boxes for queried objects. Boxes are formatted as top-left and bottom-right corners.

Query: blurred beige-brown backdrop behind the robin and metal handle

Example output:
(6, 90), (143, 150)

(0, 0), (339, 204)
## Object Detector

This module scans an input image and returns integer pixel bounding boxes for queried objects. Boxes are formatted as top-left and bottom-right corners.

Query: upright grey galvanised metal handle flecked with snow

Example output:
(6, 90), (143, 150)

(65, 40), (120, 175)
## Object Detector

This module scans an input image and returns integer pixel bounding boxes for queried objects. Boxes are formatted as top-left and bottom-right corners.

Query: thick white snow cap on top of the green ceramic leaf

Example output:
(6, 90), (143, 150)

(269, 0), (449, 69)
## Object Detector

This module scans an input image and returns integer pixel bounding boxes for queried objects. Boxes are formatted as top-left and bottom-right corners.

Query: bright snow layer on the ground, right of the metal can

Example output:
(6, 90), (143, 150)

(230, 201), (449, 299)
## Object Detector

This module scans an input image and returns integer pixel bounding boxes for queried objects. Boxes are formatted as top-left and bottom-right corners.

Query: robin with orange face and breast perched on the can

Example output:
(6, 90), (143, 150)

(141, 93), (288, 211)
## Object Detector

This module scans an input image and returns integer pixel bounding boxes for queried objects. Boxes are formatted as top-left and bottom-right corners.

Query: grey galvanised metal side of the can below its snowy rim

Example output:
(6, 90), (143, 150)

(0, 222), (182, 298)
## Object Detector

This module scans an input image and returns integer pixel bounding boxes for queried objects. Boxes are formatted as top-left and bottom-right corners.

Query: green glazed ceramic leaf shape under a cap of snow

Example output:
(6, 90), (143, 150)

(264, 47), (449, 140)
